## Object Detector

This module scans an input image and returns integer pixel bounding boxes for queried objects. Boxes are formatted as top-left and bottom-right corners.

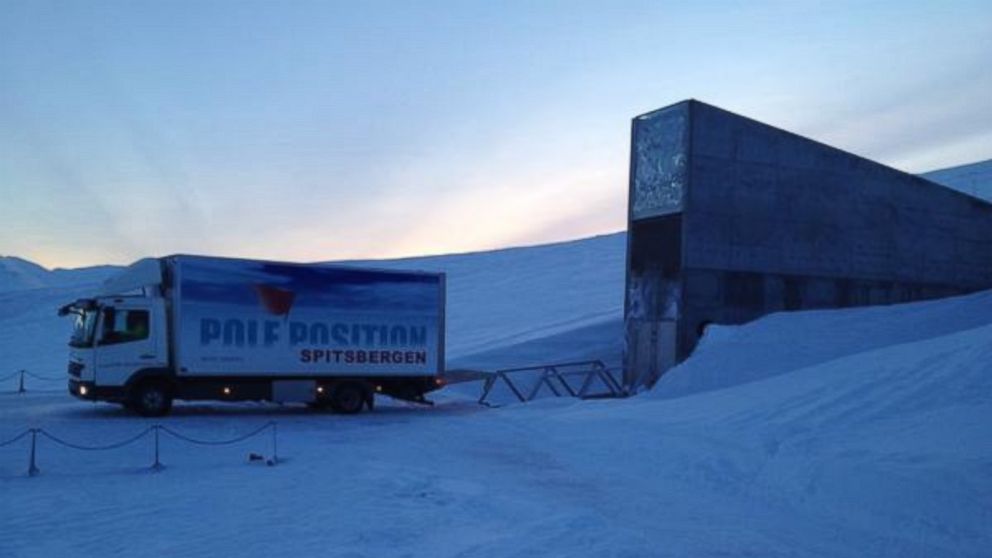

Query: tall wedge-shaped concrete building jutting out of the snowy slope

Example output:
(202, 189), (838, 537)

(625, 101), (992, 388)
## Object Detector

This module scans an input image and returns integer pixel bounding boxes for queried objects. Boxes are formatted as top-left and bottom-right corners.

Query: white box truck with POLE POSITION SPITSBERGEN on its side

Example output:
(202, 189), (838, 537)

(59, 255), (445, 416)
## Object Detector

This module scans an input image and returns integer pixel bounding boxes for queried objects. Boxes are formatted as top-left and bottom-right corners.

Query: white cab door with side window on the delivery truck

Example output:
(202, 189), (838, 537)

(95, 301), (168, 386)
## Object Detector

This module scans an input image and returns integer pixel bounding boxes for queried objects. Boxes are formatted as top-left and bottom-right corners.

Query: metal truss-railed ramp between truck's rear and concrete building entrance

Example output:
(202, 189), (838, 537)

(479, 360), (624, 407)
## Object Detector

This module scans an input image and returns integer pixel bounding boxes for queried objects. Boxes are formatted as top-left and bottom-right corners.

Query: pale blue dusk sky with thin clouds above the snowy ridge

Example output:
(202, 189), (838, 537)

(0, 0), (992, 267)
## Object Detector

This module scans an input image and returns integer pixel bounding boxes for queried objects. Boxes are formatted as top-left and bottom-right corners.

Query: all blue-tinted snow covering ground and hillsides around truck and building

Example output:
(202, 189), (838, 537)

(0, 160), (992, 557)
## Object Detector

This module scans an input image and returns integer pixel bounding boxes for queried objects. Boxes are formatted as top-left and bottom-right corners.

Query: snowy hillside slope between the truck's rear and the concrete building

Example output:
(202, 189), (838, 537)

(338, 233), (627, 368)
